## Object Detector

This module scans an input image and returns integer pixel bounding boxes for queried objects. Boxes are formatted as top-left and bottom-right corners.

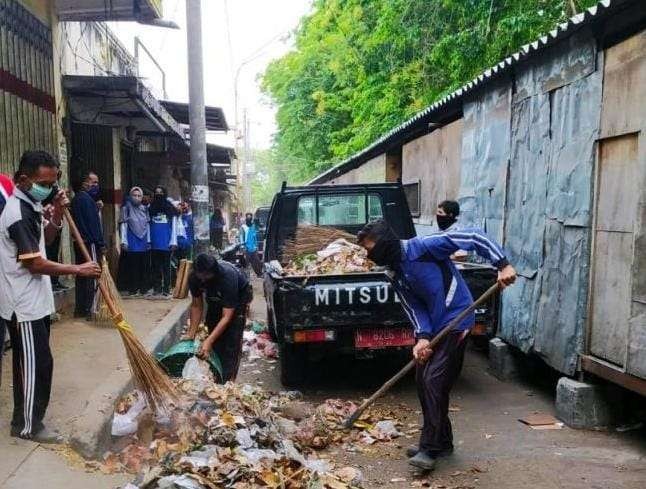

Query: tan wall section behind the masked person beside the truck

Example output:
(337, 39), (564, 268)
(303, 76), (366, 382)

(402, 119), (464, 233)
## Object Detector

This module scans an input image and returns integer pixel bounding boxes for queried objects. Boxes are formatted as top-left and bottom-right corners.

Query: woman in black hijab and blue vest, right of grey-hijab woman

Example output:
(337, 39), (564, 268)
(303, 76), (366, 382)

(148, 186), (178, 299)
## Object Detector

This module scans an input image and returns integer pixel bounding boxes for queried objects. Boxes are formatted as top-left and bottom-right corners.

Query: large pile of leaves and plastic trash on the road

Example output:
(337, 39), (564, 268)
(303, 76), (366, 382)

(99, 358), (410, 489)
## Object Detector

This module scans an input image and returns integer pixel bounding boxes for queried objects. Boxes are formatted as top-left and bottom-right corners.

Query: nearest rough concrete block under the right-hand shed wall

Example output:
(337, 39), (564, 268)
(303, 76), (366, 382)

(556, 377), (622, 429)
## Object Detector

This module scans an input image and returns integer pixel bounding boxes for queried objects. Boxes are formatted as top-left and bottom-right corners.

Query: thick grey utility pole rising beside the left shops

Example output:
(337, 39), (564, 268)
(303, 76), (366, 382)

(186, 0), (210, 254)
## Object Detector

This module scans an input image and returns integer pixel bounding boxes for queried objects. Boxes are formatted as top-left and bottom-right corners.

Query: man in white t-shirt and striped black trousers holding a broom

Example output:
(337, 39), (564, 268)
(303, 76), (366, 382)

(0, 151), (101, 443)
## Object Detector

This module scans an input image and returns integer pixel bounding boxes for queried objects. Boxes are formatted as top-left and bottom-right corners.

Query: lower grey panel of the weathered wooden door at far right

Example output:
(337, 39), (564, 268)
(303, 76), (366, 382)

(590, 231), (633, 366)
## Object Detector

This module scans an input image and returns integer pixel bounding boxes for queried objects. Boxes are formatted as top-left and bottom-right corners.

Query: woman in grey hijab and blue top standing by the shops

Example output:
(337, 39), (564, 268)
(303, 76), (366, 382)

(120, 187), (150, 297)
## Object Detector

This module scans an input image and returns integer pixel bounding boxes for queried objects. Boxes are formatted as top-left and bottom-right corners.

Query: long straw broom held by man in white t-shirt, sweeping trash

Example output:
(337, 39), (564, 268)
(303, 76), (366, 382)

(64, 209), (179, 412)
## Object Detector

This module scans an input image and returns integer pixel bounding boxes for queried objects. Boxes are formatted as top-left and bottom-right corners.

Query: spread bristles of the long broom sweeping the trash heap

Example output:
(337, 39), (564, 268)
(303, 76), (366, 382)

(118, 328), (179, 413)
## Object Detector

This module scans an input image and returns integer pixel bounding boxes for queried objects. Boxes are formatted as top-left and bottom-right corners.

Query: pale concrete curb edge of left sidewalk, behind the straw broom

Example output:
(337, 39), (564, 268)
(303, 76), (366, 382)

(69, 301), (190, 458)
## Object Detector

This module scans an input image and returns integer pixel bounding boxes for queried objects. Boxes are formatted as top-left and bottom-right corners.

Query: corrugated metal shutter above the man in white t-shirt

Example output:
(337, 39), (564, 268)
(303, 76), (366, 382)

(0, 0), (57, 174)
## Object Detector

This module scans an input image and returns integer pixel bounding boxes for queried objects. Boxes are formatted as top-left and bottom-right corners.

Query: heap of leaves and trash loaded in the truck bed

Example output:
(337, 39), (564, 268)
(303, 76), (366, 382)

(284, 238), (375, 275)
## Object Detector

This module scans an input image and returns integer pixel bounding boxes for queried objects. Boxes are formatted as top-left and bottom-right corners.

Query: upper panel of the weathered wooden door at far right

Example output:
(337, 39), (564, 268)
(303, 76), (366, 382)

(596, 134), (639, 233)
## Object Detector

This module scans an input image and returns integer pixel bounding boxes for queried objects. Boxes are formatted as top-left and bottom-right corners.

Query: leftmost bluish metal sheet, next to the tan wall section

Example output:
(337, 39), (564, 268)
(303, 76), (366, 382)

(458, 79), (511, 242)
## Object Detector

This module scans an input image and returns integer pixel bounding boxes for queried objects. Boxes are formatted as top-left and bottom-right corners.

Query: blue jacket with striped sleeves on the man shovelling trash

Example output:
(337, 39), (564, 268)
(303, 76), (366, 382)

(394, 229), (508, 339)
